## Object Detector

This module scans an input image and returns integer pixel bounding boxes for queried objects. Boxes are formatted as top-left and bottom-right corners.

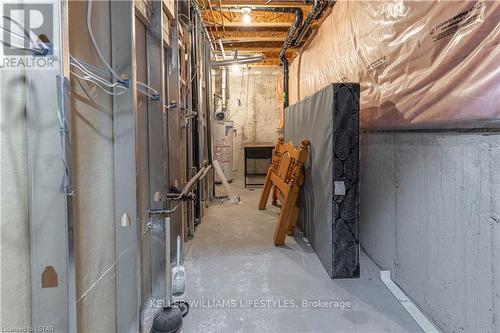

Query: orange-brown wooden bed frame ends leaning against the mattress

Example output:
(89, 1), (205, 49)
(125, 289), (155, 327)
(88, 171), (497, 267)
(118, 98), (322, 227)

(259, 137), (310, 245)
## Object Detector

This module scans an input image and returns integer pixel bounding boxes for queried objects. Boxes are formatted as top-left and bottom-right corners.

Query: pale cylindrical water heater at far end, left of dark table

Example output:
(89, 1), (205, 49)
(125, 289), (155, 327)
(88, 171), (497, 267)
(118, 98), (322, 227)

(213, 120), (234, 183)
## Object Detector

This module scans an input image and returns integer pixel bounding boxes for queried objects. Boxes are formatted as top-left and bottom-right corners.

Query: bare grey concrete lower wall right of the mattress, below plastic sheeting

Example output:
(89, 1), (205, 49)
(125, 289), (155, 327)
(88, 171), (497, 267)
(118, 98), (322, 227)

(360, 133), (500, 332)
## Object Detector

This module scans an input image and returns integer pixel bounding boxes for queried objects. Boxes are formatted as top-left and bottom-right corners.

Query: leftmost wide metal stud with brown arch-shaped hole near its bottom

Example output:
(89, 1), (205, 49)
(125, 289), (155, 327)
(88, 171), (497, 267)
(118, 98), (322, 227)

(26, 0), (77, 332)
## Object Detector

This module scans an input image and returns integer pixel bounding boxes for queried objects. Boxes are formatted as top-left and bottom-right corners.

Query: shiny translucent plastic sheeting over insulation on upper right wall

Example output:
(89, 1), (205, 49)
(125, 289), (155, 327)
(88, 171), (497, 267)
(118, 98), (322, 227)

(290, 1), (500, 129)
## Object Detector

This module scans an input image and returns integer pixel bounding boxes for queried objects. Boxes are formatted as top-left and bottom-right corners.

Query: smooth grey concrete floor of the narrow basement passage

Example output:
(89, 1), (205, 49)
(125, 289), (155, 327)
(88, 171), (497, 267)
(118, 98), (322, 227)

(183, 181), (421, 332)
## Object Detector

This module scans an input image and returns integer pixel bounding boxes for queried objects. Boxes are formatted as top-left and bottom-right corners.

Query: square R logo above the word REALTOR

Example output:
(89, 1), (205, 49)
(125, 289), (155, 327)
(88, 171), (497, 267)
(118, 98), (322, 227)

(1, 3), (54, 56)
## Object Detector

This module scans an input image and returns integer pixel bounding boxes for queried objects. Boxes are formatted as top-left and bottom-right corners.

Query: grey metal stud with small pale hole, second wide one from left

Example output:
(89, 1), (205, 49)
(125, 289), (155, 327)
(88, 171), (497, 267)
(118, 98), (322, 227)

(110, 1), (140, 333)
